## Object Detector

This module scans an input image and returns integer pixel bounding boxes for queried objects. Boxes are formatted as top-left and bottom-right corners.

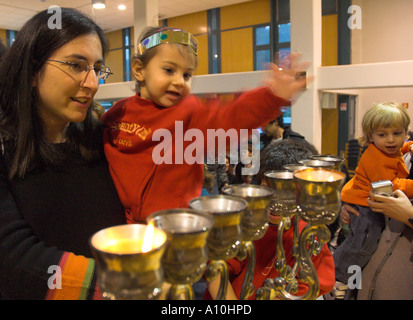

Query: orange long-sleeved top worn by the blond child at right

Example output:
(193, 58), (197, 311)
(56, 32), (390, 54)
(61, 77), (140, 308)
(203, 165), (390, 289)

(341, 141), (413, 207)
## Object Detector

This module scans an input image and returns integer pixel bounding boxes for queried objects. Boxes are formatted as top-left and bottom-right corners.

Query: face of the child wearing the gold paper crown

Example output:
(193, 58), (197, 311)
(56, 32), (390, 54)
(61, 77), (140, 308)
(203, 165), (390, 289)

(135, 44), (195, 107)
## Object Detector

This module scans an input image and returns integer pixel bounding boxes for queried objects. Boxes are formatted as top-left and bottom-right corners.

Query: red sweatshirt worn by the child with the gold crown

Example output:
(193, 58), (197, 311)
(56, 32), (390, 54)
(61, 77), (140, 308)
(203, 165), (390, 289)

(102, 88), (288, 223)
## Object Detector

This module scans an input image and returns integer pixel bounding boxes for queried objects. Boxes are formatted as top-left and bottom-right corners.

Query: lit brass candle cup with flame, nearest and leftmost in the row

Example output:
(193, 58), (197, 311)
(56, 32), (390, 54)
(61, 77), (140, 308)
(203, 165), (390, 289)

(89, 224), (167, 300)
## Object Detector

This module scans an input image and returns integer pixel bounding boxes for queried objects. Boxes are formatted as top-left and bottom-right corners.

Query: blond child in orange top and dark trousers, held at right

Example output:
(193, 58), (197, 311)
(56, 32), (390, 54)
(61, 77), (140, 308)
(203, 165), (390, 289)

(325, 103), (413, 299)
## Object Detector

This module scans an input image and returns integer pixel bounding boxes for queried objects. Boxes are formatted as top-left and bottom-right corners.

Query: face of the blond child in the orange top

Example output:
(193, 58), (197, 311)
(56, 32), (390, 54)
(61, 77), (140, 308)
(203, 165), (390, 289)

(370, 127), (407, 156)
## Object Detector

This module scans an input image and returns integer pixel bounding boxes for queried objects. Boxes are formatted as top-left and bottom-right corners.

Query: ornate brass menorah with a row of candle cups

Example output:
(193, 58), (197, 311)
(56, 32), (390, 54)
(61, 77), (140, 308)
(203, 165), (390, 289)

(90, 166), (345, 300)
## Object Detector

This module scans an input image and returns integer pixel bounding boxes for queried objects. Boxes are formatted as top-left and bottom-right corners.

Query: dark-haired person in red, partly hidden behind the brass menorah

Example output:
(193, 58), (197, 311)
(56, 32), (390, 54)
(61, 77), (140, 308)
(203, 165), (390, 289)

(204, 139), (335, 300)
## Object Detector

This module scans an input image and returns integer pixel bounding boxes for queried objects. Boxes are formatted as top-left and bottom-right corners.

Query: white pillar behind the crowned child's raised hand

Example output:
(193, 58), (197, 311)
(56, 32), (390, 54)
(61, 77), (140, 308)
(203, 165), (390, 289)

(290, 0), (322, 152)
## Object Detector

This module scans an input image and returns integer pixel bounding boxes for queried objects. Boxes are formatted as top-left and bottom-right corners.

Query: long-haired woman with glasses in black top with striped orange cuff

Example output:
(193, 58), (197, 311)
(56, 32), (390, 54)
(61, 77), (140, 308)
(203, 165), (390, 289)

(0, 8), (126, 299)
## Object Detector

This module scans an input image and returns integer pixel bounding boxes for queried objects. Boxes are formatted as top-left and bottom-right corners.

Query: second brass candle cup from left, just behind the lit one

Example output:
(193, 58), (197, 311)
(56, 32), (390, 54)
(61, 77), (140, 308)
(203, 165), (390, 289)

(147, 209), (214, 300)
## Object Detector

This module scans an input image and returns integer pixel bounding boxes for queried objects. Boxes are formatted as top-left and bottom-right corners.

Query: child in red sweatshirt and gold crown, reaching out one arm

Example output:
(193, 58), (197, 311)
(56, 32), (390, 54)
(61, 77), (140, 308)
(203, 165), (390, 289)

(102, 27), (308, 223)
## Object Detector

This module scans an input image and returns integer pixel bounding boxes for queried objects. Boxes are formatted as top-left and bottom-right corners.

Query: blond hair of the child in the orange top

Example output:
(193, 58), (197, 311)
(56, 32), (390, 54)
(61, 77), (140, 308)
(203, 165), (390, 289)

(359, 102), (410, 146)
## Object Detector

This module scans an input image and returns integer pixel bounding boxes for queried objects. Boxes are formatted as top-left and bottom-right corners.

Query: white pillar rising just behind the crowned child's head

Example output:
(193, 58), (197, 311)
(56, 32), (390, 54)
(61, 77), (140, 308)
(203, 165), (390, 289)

(133, 0), (159, 53)
